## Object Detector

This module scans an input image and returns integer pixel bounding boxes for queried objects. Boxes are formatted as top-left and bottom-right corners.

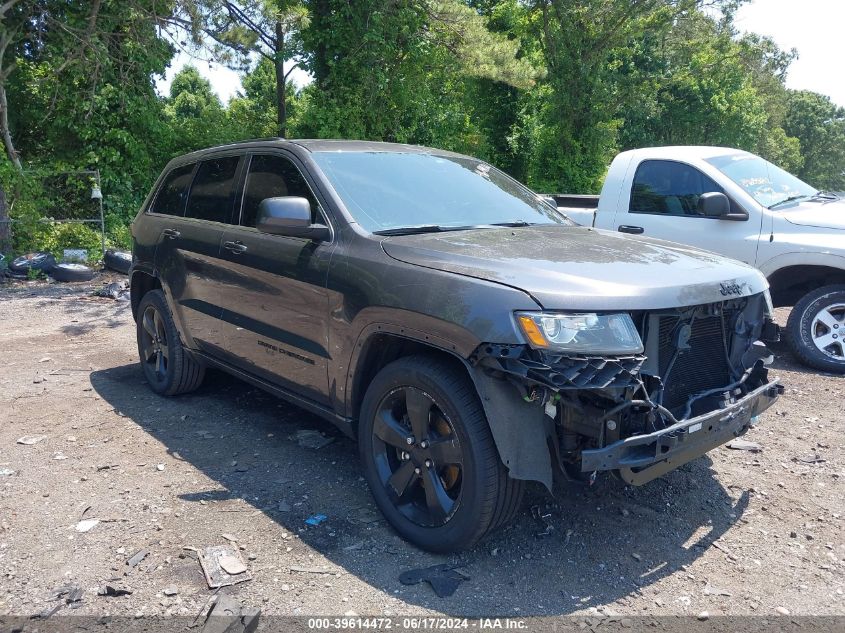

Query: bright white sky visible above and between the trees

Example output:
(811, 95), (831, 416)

(157, 0), (845, 106)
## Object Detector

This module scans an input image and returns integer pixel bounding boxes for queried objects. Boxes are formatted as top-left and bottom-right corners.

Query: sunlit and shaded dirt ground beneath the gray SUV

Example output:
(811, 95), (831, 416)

(0, 280), (845, 617)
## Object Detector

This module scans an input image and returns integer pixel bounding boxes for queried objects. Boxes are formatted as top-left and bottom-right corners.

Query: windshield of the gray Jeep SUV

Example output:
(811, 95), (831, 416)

(312, 152), (572, 232)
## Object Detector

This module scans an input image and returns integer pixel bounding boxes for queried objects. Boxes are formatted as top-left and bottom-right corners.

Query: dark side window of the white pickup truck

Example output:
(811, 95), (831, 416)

(630, 160), (724, 217)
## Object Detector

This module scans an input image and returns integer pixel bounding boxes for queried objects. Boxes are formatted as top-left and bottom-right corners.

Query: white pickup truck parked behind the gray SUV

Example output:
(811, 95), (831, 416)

(549, 147), (845, 373)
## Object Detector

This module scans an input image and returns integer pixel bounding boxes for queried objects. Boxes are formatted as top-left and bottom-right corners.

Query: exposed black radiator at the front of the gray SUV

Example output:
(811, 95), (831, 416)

(658, 314), (731, 415)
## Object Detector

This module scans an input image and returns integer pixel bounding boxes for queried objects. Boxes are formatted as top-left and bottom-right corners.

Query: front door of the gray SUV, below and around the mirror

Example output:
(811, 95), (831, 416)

(214, 153), (334, 403)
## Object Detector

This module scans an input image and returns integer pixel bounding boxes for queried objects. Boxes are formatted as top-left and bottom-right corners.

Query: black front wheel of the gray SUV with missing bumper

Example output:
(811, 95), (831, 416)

(358, 356), (524, 553)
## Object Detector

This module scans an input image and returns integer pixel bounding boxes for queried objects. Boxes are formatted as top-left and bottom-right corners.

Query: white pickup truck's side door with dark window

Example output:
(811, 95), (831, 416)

(613, 160), (762, 266)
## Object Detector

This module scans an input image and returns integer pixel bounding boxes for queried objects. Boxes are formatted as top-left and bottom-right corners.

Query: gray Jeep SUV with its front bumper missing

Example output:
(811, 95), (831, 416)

(131, 140), (781, 552)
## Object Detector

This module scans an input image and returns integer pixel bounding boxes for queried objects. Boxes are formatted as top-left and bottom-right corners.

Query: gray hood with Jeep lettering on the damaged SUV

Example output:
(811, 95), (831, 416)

(382, 225), (768, 310)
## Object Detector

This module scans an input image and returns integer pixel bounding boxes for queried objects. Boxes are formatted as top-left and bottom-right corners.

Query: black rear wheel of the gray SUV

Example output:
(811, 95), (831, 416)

(137, 290), (205, 396)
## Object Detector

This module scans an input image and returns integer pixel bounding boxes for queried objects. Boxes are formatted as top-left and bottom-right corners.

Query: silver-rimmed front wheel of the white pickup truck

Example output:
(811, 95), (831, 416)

(786, 285), (845, 373)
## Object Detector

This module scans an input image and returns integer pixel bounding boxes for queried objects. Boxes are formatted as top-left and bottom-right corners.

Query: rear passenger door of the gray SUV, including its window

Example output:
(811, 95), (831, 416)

(154, 155), (242, 355)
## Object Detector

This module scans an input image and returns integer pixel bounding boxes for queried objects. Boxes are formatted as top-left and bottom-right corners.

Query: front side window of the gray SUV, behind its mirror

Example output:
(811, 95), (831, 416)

(241, 154), (320, 226)
